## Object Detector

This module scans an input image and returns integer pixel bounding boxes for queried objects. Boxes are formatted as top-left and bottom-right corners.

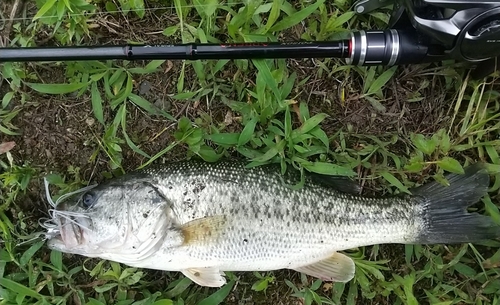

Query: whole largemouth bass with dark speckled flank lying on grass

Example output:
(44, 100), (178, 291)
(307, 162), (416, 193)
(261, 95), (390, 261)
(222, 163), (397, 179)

(44, 161), (500, 287)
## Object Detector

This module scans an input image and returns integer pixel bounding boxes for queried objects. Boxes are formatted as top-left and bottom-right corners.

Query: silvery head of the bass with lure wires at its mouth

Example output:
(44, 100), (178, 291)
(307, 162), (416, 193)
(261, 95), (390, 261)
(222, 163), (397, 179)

(48, 179), (175, 261)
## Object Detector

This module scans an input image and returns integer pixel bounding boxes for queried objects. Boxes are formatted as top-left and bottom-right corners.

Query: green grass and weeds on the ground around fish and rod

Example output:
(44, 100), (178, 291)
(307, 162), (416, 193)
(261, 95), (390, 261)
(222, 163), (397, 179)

(0, 0), (500, 305)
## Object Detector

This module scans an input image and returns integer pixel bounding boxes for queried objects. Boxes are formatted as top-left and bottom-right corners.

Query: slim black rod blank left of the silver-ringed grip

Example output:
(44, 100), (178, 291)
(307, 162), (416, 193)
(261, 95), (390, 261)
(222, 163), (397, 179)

(0, 40), (350, 62)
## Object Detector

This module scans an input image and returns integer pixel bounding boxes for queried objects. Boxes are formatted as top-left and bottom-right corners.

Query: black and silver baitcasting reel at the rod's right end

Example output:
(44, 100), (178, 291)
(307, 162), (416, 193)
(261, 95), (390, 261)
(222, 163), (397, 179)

(352, 0), (500, 77)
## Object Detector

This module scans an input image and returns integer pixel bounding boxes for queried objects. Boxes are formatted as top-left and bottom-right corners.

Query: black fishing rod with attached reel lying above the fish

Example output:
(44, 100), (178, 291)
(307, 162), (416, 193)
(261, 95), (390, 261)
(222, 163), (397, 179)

(0, 0), (500, 77)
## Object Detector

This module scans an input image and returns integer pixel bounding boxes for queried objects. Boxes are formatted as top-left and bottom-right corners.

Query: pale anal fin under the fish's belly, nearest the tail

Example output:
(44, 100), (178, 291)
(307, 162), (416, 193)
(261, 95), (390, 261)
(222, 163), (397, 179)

(294, 253), (355, 283)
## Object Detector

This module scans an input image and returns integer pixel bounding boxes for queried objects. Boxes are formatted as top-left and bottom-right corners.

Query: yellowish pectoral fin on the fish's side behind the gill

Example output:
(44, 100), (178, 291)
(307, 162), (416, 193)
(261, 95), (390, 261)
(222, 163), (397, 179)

(180, 216), (227, 245)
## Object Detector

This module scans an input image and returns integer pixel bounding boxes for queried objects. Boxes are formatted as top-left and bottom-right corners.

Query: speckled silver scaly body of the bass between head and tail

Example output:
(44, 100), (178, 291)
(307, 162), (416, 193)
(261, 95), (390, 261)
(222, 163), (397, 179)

(147, 163), (415, 264)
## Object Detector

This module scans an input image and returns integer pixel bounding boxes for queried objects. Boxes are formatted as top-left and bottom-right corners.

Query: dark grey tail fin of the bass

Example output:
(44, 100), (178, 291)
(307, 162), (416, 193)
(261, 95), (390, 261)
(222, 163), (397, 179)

(412, 164), (500, 244)
